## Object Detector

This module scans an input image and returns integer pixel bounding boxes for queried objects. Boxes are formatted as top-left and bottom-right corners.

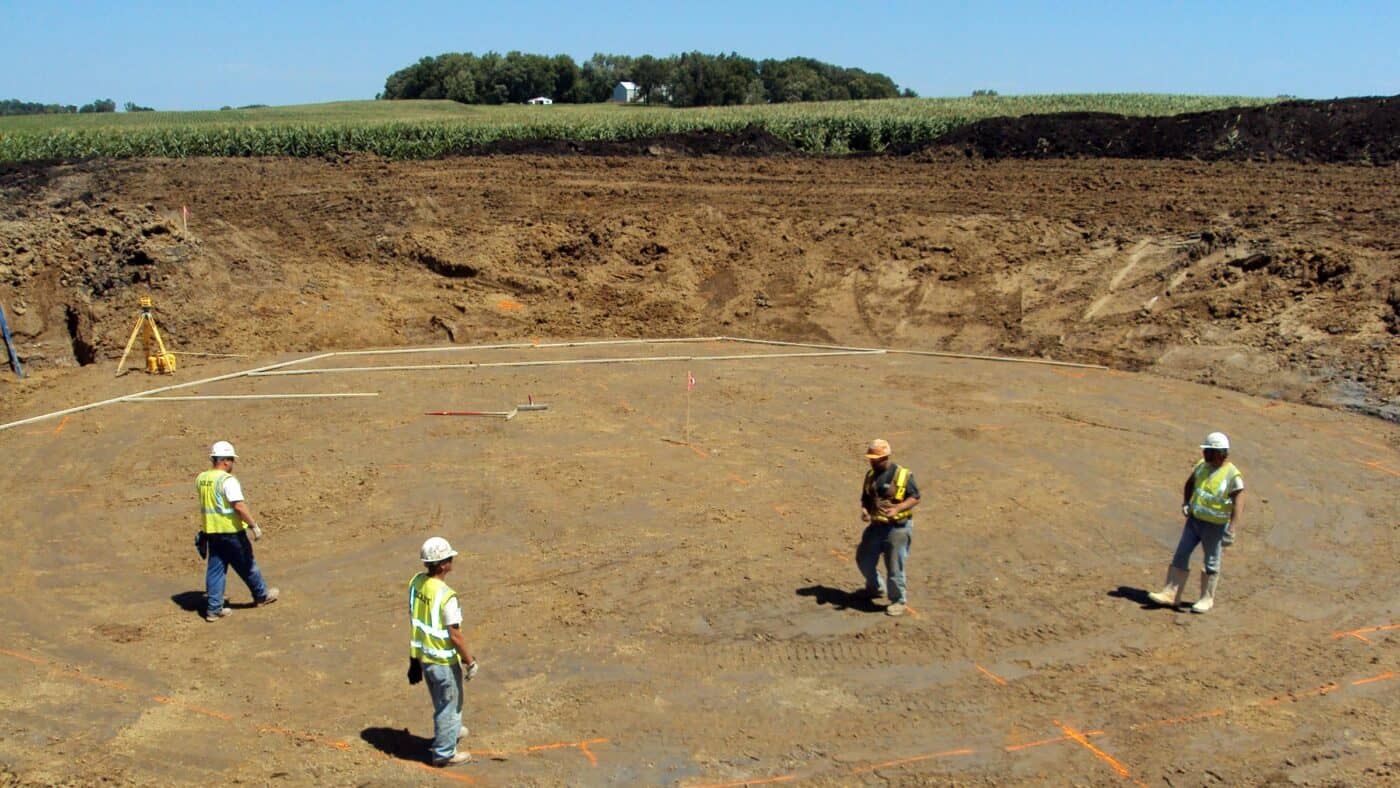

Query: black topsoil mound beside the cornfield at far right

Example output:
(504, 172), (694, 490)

(929, 97), (1400, 165)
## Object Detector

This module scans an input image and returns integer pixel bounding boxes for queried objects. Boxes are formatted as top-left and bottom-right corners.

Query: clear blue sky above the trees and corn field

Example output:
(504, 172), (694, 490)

(0, 0), (1400, 109)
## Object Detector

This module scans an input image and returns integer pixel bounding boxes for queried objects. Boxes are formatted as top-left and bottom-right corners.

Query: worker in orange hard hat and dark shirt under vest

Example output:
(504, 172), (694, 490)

(855, 438), (918, 616)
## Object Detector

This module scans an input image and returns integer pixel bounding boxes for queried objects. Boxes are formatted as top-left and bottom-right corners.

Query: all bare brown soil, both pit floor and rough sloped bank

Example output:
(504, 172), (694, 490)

(0, 155), (1400, 785)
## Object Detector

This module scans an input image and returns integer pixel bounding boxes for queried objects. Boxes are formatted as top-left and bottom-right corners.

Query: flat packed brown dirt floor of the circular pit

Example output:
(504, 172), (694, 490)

(0, 342), (1400, 787)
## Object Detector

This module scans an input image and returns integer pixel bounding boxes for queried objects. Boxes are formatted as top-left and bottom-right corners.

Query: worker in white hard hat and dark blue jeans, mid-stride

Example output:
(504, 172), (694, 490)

(195, 441), (279, 623)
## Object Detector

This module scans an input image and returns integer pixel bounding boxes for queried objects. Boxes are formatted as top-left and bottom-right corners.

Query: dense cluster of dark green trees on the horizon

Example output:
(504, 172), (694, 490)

(377, 52), (914, 106)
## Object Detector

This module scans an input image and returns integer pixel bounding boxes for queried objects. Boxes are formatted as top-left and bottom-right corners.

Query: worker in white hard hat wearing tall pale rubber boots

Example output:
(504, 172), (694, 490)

(1148, 432), (1245, 613)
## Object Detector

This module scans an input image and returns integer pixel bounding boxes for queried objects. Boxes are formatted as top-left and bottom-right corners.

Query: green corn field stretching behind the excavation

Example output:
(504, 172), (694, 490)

(0, 94), (1274, 161)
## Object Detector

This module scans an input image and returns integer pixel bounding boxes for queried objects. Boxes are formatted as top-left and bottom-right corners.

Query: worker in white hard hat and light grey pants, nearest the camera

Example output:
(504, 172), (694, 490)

(409, 536), (476, 767)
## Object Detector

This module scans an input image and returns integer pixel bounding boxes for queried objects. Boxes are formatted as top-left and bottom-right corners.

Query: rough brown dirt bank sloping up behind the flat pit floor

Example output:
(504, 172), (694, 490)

(0, 149), (1400, 418)
